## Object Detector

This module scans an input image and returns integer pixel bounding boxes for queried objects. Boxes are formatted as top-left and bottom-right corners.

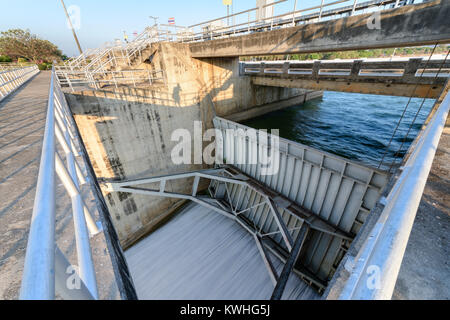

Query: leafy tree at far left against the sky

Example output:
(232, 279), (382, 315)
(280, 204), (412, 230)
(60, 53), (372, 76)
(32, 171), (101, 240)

(0, 29), (62, 63)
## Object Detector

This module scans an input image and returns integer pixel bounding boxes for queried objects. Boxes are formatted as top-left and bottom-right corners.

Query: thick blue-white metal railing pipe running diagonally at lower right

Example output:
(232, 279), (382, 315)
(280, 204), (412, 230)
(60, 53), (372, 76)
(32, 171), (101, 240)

(339, 89), (450, 300)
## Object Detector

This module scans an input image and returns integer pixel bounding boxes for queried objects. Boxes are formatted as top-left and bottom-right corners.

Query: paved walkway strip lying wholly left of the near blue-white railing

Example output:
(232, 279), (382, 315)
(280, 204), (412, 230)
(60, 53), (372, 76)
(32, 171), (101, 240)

(0, 72), (51, 300)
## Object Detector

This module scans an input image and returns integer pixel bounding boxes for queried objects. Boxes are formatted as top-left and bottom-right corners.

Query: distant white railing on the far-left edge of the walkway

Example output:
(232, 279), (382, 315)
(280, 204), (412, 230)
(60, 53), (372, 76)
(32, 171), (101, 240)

(0, 64), (39, 101)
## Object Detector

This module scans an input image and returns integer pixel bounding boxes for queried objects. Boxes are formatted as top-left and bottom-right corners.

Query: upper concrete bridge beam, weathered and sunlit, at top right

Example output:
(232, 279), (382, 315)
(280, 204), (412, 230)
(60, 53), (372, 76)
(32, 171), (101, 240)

(189, 0), (450, 58)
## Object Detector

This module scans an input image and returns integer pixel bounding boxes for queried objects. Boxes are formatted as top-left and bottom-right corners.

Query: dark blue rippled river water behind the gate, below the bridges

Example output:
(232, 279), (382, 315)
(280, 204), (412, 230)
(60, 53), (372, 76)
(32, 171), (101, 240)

(242, 91), (434, 169)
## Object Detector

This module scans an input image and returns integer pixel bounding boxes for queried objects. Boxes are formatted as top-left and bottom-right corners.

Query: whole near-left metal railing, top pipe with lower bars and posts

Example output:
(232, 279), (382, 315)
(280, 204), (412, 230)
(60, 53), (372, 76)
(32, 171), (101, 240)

(20, 69), (100, 300)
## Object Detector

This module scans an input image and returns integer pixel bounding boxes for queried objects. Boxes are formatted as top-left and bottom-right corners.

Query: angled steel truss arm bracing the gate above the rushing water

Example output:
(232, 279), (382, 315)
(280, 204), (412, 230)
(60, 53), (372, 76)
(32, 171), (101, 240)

(104, 165), (353, 300)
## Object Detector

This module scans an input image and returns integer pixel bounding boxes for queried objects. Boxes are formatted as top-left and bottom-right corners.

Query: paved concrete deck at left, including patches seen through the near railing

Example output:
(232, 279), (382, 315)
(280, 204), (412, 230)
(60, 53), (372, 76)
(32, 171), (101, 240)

(0, 72), (119, 300)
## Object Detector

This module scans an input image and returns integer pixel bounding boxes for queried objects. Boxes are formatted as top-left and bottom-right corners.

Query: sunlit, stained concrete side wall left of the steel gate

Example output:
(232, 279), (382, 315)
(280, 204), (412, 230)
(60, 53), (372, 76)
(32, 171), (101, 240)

(66, 43), (320, 247)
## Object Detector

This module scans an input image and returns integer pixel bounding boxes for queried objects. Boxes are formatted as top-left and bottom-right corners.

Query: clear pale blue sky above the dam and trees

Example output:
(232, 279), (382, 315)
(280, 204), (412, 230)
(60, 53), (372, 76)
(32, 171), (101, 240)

(0, 0), (324, 56)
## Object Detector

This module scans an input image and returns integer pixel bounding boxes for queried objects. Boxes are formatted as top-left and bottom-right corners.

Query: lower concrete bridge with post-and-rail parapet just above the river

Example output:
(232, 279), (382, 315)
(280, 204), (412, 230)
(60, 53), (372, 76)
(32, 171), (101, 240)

(240, 58), (450, 98)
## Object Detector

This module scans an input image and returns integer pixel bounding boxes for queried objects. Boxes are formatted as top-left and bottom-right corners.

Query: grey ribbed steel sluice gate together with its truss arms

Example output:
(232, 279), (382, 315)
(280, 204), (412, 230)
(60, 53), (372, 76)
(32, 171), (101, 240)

(108, 117), (388, 299)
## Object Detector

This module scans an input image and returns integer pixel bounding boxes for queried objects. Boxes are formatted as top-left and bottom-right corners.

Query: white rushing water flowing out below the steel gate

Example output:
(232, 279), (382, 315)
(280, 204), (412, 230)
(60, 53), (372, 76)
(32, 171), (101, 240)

(125, 203), (320, 300)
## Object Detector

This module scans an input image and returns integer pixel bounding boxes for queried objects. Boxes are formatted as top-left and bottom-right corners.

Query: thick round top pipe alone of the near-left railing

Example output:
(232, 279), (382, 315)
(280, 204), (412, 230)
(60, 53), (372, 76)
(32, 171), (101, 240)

(20, 68), (56, 300)
